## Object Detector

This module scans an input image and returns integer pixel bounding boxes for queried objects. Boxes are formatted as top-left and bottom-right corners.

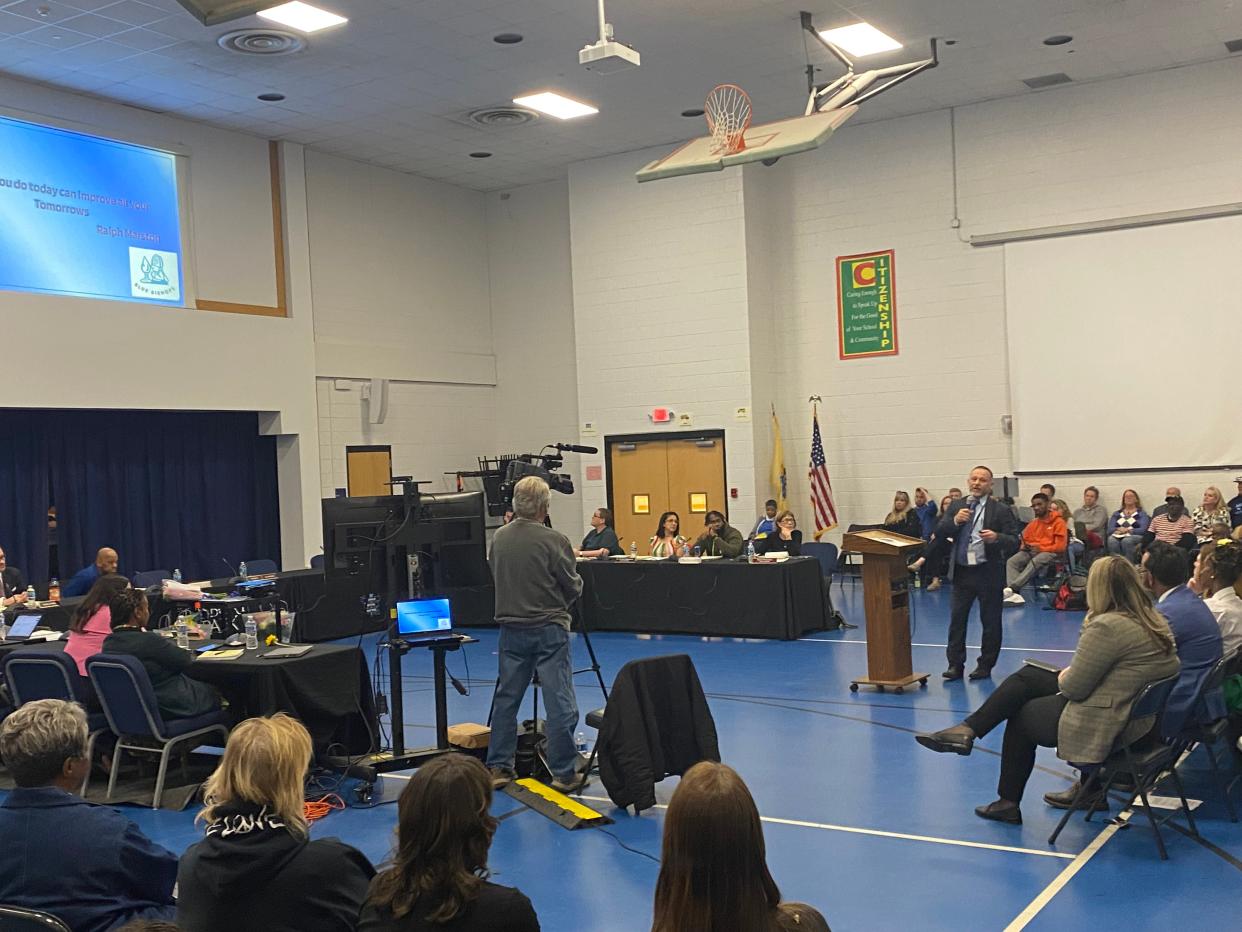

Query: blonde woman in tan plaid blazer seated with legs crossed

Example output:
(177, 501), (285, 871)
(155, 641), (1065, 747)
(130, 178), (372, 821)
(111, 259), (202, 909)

(915, 557), (1180, 825)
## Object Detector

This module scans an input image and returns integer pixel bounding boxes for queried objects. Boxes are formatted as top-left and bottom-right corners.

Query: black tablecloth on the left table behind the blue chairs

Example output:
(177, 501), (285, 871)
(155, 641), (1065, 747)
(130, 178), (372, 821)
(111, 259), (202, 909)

(0, 640), (375, 754)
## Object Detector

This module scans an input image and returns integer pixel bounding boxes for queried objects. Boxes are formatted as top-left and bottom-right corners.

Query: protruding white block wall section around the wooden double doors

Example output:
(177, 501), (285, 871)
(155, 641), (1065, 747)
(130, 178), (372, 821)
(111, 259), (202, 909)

(569, 150), (755, 536)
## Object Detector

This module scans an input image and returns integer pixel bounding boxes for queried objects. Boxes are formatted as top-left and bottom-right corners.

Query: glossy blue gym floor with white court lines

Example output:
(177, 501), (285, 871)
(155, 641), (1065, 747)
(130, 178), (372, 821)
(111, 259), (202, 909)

(12, 583), (1242, 932)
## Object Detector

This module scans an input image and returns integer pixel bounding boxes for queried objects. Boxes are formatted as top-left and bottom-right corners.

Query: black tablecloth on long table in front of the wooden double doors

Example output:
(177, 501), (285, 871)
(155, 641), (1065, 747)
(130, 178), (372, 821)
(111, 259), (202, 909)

(578, 557), (828, 640)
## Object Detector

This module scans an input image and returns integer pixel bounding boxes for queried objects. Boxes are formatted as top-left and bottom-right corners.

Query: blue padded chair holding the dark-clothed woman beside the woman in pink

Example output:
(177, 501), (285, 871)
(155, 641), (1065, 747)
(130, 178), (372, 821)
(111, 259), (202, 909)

(86, 654), (229, 809)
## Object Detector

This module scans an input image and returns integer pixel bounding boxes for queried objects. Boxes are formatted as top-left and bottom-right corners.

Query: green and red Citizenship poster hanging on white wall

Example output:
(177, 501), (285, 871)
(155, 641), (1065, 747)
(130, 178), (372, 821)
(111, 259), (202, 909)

(837, 250), (897, 359)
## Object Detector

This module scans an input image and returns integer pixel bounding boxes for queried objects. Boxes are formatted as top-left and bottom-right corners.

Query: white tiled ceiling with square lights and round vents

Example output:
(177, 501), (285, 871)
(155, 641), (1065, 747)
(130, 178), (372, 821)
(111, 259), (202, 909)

(0, 0), (1242, 190)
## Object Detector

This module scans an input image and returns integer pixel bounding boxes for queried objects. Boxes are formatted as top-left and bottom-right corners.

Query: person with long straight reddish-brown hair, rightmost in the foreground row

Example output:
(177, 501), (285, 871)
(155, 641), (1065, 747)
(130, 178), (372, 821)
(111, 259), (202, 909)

(651, 761), (828, 932)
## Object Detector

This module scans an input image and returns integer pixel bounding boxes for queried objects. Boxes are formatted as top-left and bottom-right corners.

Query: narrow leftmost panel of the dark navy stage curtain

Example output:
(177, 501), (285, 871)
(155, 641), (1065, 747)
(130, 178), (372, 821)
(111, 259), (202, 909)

(0, 410), (50, 585)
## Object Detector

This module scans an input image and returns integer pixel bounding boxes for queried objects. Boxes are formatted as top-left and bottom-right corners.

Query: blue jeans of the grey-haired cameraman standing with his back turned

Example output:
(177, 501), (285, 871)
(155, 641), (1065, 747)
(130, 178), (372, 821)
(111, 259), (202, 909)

(487, 623), (578, 780)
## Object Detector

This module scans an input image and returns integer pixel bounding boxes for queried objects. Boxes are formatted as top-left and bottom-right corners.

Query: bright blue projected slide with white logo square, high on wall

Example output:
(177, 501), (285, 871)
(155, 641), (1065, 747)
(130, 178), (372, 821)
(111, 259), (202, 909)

(0, 117), (183, 304)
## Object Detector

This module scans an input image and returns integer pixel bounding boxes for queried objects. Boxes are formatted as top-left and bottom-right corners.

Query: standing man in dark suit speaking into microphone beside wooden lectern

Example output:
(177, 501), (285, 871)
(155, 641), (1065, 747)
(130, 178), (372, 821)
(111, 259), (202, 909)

(936, 466), (1018, 681)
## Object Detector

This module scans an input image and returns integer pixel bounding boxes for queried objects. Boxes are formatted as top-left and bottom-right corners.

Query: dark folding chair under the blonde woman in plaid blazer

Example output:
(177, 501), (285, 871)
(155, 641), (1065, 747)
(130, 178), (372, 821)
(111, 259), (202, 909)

(1048, 674), (1199, 861)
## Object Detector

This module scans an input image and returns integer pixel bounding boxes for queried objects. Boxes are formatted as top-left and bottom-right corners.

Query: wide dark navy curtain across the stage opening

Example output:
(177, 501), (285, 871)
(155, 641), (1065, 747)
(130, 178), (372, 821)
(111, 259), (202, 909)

(0, 410), (281, 580)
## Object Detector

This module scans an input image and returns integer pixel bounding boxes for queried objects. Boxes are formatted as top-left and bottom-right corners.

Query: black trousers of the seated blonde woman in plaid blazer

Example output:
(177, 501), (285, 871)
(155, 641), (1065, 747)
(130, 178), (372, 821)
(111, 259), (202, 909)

(965, 666), (1068, 803)
